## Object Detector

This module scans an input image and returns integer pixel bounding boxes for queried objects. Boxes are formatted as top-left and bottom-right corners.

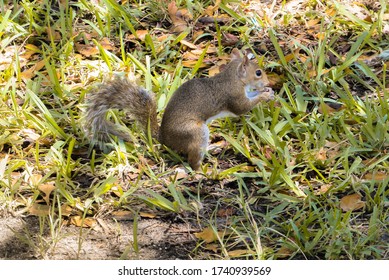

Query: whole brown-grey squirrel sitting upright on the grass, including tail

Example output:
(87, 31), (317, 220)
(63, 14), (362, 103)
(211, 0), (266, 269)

(84, 49), (274, 171)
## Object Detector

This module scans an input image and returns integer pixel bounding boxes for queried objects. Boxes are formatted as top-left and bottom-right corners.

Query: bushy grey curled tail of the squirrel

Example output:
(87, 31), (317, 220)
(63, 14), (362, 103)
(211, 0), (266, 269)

(83, 77), (159, 142)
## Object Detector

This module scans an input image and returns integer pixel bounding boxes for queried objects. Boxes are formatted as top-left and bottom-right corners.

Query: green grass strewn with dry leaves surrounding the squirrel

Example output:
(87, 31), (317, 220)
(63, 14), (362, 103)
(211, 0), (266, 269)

(0, 0), (389, 259)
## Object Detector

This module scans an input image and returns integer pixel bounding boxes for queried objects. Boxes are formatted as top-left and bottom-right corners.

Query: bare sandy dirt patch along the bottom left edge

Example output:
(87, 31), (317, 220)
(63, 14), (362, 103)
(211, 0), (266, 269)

(0, 213), (196, 260)
